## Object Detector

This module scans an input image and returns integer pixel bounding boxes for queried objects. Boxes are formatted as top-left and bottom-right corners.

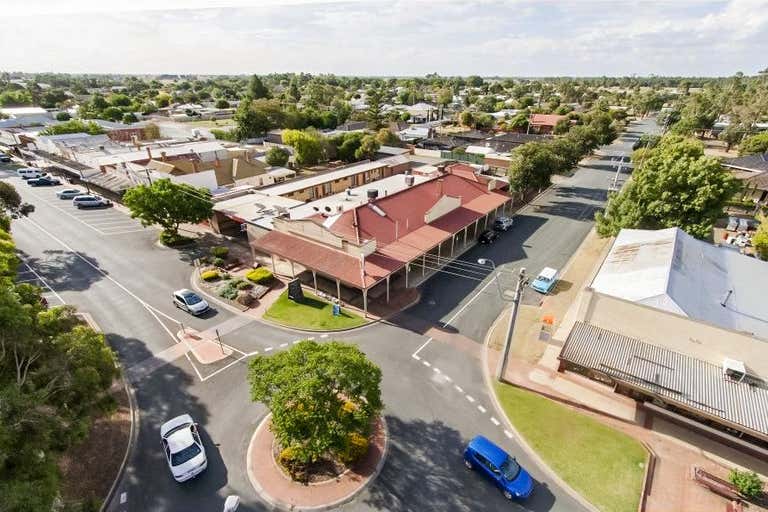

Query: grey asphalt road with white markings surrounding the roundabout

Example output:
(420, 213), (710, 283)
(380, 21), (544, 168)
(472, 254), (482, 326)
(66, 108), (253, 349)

(0, 118), (653, 512)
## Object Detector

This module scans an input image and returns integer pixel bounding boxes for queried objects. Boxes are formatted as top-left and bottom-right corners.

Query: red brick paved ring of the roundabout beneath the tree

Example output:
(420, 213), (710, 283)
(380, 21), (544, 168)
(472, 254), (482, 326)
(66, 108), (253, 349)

(246, 414), (389, 511)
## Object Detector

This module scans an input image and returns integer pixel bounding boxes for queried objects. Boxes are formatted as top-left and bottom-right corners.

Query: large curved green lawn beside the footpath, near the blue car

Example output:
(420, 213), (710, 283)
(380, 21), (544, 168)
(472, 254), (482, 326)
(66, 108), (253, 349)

(496, 384), (646, 512)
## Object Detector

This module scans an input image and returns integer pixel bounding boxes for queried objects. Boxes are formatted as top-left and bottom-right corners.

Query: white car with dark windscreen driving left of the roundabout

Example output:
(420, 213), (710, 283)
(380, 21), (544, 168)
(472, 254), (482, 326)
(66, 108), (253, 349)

(160, 414), (208, 482)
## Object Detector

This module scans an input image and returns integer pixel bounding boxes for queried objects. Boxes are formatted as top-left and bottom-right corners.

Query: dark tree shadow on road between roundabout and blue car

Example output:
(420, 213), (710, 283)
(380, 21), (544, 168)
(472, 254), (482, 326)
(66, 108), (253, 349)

(362, 416), (555, 512)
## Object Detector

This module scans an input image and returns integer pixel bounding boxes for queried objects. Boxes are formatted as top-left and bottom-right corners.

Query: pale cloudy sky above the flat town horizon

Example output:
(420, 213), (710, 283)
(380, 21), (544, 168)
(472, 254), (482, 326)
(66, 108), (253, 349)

(0, 0), (768, 77)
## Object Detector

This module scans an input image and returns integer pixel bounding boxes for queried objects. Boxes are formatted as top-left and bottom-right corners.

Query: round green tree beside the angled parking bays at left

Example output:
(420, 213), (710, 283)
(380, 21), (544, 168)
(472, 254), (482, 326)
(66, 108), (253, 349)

(123, 178), (213, 241)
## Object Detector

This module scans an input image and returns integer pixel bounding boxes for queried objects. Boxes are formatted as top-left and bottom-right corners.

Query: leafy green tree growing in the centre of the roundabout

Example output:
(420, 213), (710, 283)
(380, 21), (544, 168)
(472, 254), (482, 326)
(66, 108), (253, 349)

(248, 340), (383, 481)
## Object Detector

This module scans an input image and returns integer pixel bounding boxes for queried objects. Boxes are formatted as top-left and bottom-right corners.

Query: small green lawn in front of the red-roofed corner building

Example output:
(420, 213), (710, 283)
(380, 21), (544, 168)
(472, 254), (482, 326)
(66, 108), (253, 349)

(264, 291), (366, 331)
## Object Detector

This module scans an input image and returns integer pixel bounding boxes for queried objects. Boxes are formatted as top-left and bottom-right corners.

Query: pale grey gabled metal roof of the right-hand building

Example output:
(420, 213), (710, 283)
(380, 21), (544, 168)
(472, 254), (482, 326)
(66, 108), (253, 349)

(592, 228), (768, 339)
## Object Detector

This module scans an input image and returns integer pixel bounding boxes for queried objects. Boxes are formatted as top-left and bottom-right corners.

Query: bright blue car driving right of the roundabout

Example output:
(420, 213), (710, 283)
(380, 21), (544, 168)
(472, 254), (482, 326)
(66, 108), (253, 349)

(464, 436), (533, 500)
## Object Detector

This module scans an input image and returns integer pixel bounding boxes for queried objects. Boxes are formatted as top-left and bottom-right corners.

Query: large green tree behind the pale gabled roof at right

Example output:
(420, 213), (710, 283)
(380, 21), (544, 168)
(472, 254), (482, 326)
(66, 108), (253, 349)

(596, 136), (739, 238)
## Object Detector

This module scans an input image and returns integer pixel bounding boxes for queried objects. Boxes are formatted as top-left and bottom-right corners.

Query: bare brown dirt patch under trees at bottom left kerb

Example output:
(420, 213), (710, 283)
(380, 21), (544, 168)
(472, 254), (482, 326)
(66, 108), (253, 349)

(59, 386), (131, 503)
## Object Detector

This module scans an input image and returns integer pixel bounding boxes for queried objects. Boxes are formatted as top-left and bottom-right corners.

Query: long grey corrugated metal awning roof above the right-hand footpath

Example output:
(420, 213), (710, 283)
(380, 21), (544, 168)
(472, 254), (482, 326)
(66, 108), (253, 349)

(560, 322), (768, 438)
